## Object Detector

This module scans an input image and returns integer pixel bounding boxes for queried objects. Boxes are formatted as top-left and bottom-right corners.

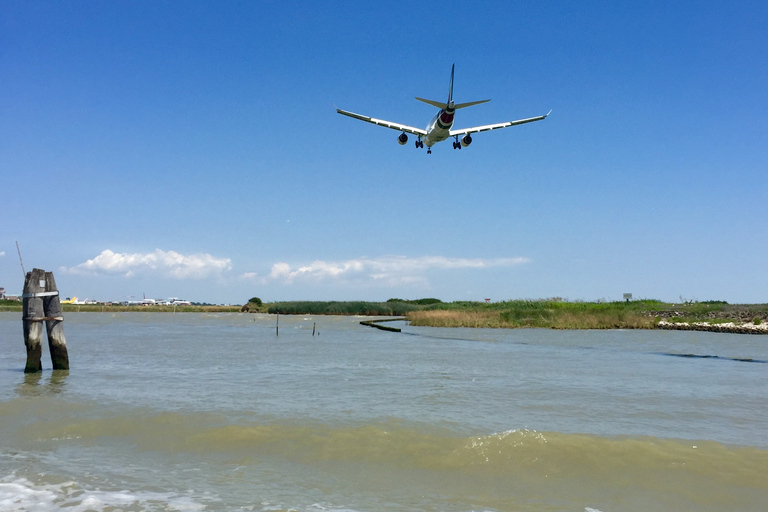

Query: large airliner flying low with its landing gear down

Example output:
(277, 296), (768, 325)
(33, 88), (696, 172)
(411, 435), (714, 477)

(336, 64), (552, 154)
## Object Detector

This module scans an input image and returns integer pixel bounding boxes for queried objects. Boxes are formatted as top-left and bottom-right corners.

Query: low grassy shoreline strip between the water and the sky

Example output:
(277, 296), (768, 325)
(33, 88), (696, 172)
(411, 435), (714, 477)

(0, 299), (768, 334)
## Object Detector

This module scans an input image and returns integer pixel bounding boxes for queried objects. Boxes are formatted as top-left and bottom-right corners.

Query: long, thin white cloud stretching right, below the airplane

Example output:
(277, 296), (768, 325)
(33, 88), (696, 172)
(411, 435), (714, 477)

(240, 256), (530, 286)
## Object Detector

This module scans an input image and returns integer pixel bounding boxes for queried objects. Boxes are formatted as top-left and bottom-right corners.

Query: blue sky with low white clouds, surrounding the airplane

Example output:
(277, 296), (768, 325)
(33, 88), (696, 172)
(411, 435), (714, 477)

(0, 0), (768, 303)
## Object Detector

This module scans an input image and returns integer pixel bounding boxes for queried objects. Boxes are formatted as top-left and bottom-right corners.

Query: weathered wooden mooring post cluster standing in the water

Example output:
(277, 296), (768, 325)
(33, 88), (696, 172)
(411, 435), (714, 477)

(22, 268), (69, 373)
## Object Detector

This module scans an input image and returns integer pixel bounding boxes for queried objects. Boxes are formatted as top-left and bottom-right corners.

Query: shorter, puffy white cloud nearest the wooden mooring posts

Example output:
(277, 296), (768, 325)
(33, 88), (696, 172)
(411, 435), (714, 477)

(63, 249), (232, 279)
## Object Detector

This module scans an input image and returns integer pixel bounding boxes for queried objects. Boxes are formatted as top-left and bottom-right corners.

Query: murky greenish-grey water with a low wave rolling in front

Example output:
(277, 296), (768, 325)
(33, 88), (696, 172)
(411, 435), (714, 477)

(0, 313), (768, 512)
